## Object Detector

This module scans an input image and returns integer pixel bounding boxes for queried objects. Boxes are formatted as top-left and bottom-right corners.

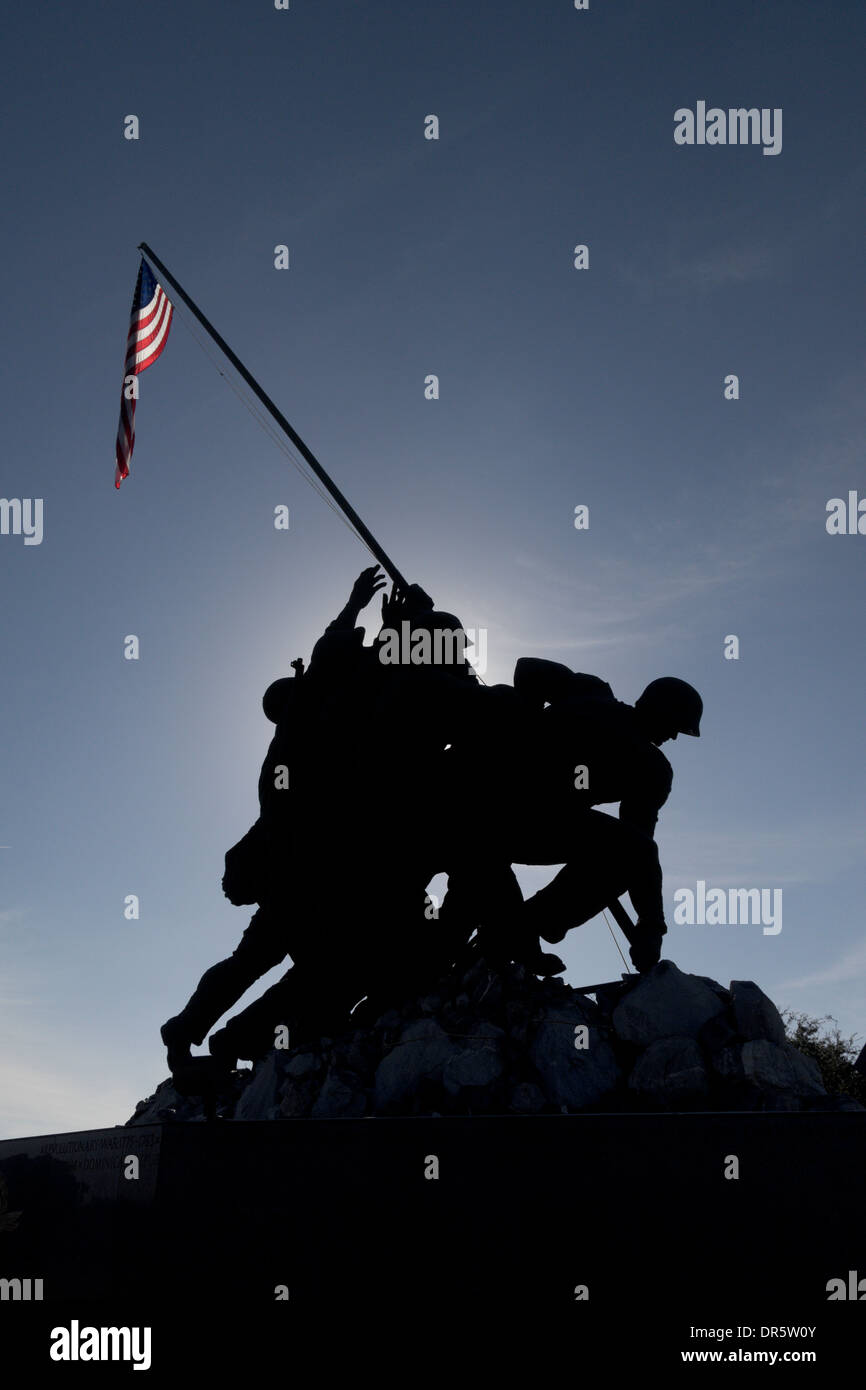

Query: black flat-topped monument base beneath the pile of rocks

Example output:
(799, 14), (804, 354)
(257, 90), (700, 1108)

(0, 1112), (866, 1373)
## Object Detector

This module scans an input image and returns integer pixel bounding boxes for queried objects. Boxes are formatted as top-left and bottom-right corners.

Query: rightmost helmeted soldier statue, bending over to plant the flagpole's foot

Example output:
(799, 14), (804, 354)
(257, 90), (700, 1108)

(496, 659), (703, 970)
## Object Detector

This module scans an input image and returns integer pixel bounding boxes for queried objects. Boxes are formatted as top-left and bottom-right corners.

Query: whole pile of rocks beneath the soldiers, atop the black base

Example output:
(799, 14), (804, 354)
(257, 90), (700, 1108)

(128, 959), (863, 1125)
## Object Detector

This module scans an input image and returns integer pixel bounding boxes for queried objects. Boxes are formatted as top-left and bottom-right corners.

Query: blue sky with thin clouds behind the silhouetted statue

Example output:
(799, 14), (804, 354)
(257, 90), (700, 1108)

(0, 0), (866, 1137)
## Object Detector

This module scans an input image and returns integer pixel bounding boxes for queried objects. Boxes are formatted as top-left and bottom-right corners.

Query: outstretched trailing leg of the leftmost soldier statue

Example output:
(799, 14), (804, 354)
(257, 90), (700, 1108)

(161, 908), (289, 1070)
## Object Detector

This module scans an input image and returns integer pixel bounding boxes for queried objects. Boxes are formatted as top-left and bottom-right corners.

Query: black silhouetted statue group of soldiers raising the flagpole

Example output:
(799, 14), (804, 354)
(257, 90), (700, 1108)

(161, 566), (702, 1073)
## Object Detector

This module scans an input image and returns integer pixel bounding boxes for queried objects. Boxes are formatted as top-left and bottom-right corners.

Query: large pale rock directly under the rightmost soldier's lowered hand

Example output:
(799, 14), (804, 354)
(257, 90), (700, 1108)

(613, 960), (724, 1047)
